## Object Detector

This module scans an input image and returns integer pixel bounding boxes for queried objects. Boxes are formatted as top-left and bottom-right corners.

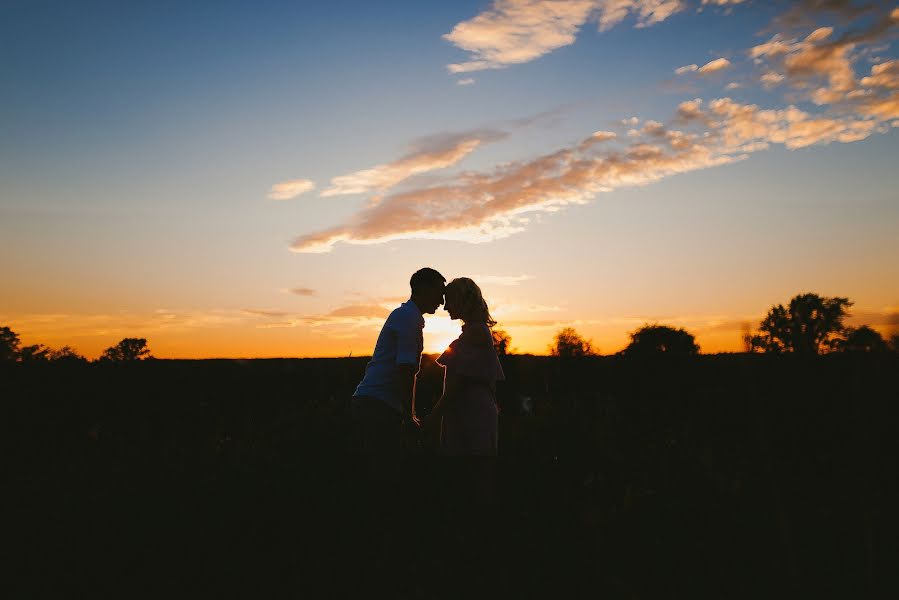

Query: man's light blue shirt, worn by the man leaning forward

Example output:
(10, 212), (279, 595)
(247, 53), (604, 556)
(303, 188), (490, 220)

(353, 300), (425, 412)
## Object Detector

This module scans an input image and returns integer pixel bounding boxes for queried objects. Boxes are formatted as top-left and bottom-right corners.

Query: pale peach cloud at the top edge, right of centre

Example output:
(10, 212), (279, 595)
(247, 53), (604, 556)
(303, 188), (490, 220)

(443, 0), (685, 73)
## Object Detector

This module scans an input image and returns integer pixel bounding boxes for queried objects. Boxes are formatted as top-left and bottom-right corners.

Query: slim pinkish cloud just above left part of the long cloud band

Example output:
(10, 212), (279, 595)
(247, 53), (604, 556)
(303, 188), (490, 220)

(321, 129), (508, 197)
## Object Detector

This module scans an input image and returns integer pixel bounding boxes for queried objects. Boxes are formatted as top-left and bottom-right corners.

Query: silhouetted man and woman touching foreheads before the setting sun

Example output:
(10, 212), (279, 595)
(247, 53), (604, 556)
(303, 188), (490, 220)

(353, 268), (503, 456)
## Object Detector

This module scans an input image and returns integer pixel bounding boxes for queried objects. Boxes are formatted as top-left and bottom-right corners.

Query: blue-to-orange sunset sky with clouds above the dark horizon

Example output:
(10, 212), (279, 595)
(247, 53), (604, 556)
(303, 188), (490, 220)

(0, 0), (899, 358)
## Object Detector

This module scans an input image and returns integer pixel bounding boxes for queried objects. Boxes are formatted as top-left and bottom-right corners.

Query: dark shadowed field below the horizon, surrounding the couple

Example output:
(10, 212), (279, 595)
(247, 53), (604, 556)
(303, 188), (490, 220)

(7, 354), (899, 598)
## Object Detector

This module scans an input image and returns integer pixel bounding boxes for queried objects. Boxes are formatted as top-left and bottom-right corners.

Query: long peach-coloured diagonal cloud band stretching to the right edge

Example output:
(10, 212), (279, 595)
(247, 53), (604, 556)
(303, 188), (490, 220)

(291, 79), (899, 252)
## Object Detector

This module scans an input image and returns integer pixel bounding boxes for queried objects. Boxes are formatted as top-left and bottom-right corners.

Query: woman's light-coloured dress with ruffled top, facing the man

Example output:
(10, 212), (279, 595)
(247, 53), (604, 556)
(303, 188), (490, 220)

(437, 323), (505, 456)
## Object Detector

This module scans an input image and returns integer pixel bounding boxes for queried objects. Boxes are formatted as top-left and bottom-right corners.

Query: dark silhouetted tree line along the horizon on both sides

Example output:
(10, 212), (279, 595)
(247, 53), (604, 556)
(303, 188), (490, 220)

(0, 293), (899, 364)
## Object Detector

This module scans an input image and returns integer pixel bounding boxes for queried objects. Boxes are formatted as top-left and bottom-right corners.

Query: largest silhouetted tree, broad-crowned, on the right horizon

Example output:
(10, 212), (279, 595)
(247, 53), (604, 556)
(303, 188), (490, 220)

(752, 294), (852, 355)
